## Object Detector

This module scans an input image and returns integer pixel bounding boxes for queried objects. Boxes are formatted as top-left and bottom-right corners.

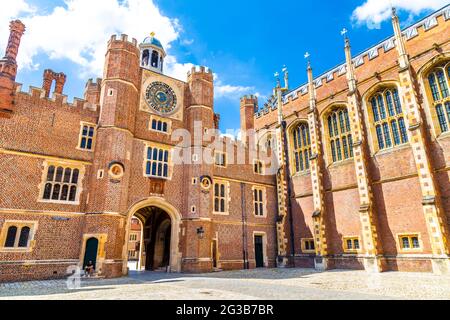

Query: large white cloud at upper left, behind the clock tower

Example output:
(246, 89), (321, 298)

(0, 0), (189, 80)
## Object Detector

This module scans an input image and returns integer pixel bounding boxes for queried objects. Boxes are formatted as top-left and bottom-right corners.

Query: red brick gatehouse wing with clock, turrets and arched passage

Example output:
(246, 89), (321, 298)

(0, 21), (277, 281)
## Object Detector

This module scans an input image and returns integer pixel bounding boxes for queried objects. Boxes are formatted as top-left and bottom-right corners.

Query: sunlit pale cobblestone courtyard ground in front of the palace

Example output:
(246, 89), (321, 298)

(0, 269), (450, 300)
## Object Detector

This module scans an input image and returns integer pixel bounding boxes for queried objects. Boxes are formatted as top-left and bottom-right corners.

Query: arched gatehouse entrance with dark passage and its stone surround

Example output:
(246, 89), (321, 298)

(123, 197), (181, 274)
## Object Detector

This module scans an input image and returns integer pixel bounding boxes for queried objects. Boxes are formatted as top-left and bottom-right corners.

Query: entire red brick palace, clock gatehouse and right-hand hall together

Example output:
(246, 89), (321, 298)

(0, 6), (450, 281)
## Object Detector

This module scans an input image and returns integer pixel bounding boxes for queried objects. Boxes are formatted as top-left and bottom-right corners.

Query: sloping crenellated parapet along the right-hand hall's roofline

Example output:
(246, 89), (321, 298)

(255, 5), (450, 118)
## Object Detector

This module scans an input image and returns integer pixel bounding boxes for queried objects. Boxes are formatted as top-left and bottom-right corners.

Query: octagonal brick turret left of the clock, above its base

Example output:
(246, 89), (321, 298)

(85, 35), (140, 218)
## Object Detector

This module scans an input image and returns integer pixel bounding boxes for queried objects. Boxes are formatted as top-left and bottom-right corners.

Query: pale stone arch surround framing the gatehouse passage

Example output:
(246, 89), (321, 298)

(122, 197), (181, 275)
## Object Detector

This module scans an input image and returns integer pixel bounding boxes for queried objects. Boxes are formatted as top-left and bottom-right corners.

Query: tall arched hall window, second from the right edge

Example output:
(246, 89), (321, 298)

(369, 87), (408, 150)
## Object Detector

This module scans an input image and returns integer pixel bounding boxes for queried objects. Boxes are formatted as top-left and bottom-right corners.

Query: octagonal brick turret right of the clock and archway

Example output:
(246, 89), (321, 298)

(184, 67), (214, 271)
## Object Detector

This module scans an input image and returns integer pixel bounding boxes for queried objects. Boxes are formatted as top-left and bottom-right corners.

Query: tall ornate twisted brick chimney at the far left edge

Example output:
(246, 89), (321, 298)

(0, 20), (25, 117)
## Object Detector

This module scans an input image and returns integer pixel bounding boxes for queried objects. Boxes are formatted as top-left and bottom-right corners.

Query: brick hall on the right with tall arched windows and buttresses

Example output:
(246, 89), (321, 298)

(255, 6), (450, 273)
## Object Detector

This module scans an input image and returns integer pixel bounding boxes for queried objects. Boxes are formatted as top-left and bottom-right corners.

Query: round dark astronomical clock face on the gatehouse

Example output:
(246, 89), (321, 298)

(145, 82), (177, 114)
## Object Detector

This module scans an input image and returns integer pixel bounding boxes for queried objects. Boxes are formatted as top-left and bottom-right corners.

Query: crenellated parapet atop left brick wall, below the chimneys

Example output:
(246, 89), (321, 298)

(16, 83), (98, 113)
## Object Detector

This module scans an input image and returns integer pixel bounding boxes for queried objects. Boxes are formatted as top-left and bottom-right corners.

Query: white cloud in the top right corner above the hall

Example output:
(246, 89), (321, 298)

(352, 0), (448, 29)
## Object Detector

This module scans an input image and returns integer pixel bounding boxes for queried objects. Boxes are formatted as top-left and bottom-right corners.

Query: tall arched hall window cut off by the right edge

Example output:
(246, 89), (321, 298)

(425, 61), (450, 133)
